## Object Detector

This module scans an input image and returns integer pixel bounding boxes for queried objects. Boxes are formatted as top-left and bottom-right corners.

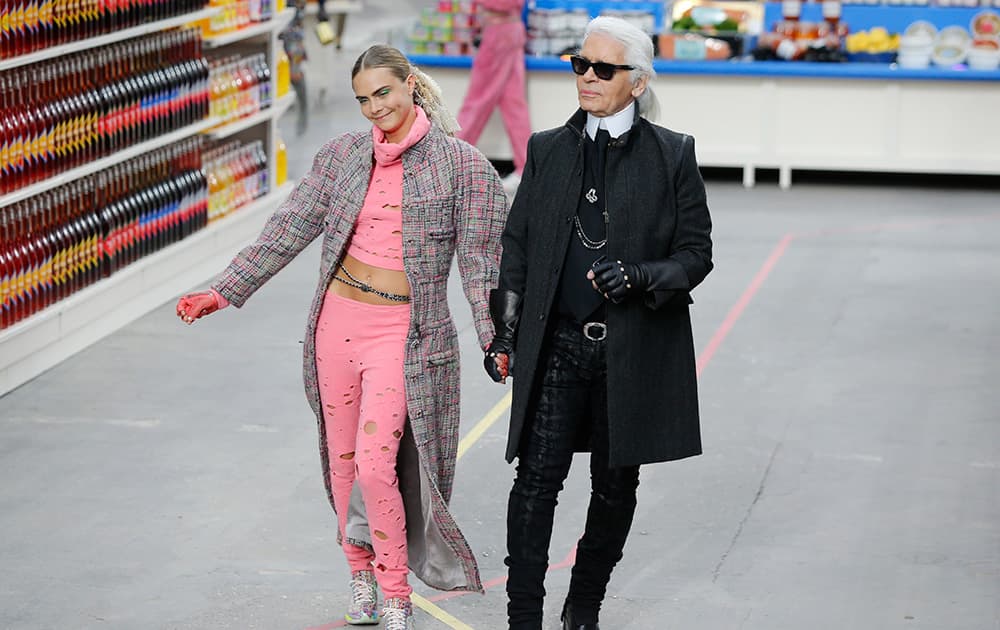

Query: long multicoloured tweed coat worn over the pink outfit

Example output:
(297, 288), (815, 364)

(213, 125), (507, 591)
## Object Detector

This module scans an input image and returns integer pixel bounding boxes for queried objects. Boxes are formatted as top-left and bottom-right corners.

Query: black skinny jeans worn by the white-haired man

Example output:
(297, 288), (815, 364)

(505, 320), (639, 630)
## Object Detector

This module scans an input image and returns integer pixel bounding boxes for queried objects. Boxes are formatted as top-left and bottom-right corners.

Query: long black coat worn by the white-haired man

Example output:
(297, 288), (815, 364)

(500, 110), (712, 466)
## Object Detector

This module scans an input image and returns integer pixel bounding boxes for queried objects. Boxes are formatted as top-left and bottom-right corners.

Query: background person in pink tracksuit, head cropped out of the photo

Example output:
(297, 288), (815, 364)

(457, 0), (531, 189)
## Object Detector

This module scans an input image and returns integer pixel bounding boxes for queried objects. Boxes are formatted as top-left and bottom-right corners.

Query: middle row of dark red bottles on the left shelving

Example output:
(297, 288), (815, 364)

(0, 29), (209, 194)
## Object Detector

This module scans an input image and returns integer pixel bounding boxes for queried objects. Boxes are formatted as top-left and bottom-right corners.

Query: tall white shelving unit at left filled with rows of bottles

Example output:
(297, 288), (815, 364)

(0, 0), (292, 350)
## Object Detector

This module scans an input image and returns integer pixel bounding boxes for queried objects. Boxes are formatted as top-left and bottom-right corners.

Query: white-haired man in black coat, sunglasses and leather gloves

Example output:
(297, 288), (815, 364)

(484, 17), (712, 630)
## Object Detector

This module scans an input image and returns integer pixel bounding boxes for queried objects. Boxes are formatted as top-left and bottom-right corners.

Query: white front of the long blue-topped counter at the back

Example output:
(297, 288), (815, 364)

(424, 57), (1000, 188)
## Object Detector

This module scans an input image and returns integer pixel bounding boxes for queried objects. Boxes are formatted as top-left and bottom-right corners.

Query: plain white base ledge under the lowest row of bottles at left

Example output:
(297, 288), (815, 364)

(0, 182), (293, 396)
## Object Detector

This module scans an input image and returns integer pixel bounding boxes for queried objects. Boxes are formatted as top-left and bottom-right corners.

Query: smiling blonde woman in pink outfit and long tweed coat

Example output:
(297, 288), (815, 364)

(177, 45), (506, 630)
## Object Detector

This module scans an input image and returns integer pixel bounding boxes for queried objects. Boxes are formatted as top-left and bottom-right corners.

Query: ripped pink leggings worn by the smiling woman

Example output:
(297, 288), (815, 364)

(316, 292), (413, 599)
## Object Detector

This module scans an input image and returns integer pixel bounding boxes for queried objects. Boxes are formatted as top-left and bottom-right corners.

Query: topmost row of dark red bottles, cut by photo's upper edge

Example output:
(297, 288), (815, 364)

(0, 0), (205, 59)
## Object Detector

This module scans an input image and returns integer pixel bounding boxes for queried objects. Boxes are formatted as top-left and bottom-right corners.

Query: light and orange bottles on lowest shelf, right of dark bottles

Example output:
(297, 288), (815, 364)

(205, 140), (270, 222)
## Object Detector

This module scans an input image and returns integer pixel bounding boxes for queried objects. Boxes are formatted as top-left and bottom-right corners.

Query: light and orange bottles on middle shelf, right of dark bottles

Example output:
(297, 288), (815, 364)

(209, 54), (274, 122)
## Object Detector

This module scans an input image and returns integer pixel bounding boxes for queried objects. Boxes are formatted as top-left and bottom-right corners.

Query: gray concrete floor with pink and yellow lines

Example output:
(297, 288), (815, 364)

(0, 2), (1000, 630)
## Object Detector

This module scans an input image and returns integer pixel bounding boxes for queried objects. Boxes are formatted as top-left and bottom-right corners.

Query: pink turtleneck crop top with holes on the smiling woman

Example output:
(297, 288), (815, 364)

(347, 107), (430, 271)
